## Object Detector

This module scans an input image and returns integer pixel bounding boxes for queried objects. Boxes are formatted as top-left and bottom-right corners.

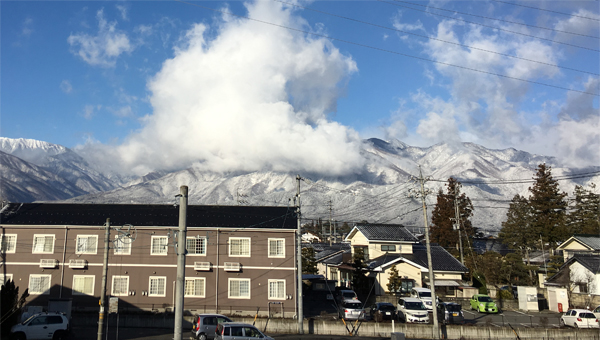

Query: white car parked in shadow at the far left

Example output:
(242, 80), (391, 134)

(10, 312), (71, 340)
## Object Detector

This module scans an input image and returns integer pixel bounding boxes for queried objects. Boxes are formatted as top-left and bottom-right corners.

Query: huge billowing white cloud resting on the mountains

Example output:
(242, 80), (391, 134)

(79, 1), (363, 174)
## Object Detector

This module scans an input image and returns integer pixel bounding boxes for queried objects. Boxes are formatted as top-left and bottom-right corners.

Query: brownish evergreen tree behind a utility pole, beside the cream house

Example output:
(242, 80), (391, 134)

(430, 177), (476, 248)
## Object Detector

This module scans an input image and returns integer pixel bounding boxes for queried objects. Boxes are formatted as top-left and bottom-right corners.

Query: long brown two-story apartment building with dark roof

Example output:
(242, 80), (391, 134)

(0, 203), (297, 316)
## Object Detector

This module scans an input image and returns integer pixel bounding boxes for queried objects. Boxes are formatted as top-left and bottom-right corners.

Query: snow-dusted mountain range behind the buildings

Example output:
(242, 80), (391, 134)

(0, 137), (600, 234)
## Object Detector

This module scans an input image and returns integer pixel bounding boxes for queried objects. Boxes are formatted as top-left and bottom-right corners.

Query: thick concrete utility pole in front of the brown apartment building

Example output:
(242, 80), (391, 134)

(173, 185), (188, 340)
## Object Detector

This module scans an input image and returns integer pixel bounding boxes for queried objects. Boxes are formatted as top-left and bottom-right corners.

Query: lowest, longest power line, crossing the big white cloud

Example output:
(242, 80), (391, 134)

(174, 0), (599, 97)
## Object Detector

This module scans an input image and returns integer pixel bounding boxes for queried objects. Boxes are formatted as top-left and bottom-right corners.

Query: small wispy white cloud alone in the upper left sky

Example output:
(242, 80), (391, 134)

(67, 10), (134, 67)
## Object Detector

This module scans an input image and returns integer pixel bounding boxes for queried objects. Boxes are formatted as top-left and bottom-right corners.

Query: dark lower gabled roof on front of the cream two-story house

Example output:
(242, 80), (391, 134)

(368, 244), (468, 273)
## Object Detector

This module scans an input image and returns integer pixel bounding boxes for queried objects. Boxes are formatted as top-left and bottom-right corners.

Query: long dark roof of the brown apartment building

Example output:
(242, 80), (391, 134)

(0, 203), (297, 229)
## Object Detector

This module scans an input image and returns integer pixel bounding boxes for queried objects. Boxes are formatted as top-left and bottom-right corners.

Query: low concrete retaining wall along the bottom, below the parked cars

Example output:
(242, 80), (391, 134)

(73, 313), (600, 340)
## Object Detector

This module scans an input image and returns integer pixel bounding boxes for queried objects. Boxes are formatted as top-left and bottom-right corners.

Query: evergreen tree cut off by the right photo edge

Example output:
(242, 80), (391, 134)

(567, 183), (600, 235)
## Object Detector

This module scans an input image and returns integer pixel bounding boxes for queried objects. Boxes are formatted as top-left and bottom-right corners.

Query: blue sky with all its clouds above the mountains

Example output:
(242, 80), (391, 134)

(0, 0), (600, 175)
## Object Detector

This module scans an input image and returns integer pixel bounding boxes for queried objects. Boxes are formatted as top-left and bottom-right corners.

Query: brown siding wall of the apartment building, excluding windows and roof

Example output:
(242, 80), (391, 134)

(0, 225), (296, 316)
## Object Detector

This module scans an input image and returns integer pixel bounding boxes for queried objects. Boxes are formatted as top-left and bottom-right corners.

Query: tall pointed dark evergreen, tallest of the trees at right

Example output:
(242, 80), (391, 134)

(529, 164), (571, 248)
